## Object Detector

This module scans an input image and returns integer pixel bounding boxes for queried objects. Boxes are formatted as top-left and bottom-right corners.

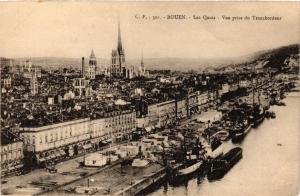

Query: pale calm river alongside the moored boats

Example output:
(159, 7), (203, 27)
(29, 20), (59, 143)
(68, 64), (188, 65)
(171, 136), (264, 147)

(150, 93), (300, 196)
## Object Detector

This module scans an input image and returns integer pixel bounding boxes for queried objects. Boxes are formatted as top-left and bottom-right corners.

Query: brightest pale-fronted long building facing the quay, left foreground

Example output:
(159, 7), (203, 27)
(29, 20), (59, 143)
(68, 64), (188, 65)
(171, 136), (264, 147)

(21, 118), (91, 164)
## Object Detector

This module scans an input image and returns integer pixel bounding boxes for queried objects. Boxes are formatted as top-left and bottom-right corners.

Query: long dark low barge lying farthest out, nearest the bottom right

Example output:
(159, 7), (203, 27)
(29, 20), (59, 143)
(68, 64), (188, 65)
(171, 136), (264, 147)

(207, 147), (243, 181)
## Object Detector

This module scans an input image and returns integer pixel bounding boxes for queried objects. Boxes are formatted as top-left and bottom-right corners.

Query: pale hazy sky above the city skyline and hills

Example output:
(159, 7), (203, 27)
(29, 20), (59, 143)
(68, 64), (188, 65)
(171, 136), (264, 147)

(0, 1), (300, 59)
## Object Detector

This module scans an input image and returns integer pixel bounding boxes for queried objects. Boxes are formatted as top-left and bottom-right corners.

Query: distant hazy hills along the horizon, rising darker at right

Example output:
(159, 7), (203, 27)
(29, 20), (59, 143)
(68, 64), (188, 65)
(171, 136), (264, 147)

(15, 44), (299, 71)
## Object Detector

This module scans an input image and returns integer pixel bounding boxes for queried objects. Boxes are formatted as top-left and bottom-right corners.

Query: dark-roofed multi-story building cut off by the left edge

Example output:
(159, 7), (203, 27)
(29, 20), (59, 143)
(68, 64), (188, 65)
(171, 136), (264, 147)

(1, 130), (24, 176)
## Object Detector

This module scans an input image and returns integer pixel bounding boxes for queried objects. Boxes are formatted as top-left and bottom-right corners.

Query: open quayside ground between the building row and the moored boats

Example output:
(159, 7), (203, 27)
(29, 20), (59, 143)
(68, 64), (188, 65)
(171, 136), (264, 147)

(2, 77), (296, 195)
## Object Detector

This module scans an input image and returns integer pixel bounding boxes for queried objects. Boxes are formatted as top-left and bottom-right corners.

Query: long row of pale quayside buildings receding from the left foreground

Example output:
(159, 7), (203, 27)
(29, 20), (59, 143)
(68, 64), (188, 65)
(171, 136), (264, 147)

(16, 84), (224, 165)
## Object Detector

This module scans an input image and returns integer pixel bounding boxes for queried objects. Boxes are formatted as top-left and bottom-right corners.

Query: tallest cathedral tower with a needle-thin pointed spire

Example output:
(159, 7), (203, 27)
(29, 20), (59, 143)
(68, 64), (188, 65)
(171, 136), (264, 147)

(110, 21), (126, 77)
